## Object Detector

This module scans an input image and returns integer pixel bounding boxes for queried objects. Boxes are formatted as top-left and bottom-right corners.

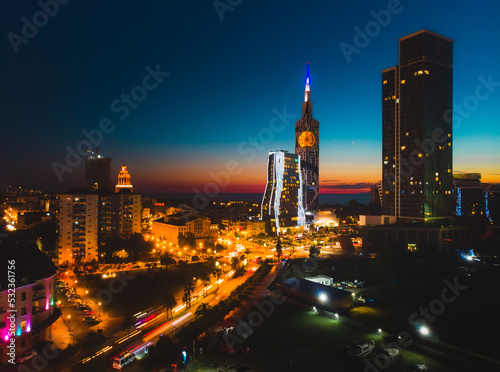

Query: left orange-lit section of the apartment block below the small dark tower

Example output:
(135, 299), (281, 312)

(58, 194), (99, 264)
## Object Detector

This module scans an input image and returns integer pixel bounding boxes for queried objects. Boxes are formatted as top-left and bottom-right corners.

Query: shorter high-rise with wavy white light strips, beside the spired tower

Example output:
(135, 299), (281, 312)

(261, 151), (306, 235)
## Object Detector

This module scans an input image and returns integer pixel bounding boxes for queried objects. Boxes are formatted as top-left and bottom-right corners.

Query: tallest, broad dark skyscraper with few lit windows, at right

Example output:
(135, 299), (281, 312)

(382, 30), (454, 219)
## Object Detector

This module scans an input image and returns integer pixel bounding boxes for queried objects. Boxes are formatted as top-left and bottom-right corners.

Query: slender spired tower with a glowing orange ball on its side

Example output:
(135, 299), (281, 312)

(295, 62), (319, 210)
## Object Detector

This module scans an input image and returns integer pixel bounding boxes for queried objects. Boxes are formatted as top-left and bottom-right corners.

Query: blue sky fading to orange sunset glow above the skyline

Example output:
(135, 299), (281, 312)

(0, 0), (500, 193)
